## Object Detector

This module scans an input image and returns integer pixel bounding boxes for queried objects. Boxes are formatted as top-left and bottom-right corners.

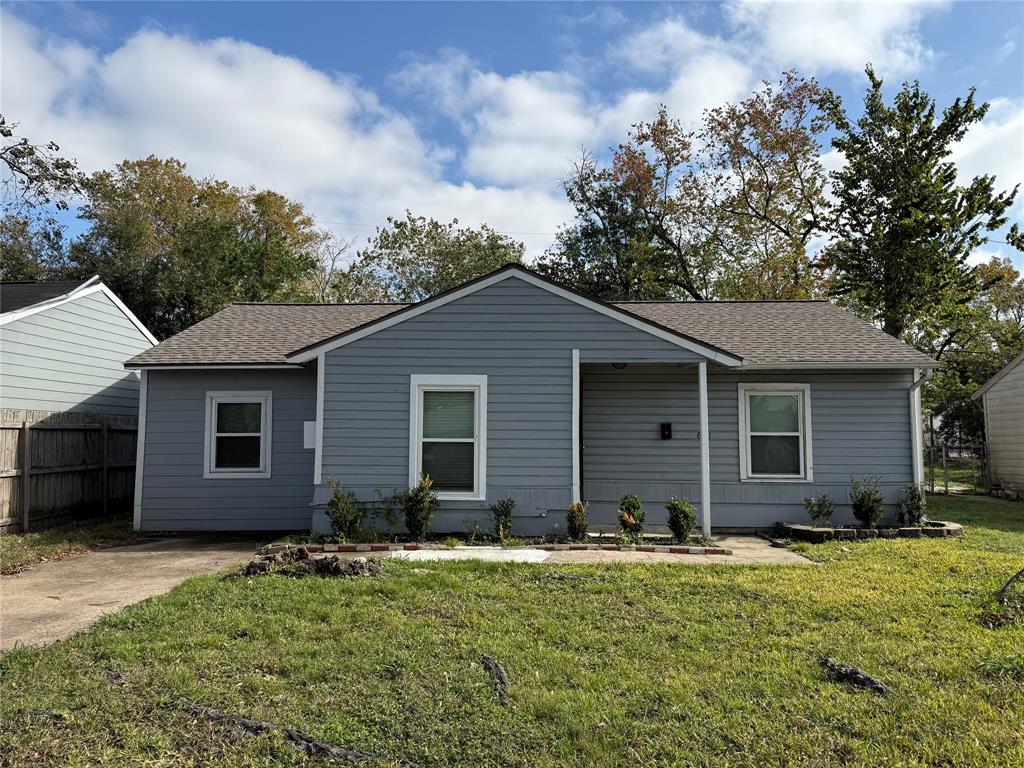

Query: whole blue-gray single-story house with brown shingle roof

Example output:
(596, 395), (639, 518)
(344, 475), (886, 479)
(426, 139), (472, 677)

(126, 265), (937, 535)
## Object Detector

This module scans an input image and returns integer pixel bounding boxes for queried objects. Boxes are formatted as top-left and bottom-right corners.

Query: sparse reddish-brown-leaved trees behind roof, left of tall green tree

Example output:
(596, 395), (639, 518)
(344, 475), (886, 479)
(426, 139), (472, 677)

(539, 72), (827, 300)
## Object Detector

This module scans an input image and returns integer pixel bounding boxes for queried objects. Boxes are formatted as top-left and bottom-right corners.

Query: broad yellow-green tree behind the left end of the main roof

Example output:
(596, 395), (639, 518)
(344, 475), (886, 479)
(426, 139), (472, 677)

(63, 157), (316, 338)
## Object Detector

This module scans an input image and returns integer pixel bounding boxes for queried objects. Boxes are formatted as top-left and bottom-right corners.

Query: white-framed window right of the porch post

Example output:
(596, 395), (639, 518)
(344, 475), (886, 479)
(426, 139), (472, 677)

(739, 384), (813, 481)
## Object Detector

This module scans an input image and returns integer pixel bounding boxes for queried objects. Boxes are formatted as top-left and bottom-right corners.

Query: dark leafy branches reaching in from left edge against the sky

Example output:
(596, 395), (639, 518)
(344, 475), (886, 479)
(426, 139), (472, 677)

(0, 115), (82, 221)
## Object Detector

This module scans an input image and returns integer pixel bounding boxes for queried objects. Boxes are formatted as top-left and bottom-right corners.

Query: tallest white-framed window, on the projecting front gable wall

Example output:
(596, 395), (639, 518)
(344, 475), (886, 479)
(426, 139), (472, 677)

(409, 376), (487, 501)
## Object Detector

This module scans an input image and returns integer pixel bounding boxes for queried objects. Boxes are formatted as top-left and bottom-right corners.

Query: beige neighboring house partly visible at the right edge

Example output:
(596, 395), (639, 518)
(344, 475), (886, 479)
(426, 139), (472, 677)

(973, 353), (1024, 499)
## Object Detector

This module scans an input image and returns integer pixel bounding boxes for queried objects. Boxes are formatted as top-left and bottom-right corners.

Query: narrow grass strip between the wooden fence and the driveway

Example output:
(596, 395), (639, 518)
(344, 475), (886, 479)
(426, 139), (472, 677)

(0, 517), (137, 573)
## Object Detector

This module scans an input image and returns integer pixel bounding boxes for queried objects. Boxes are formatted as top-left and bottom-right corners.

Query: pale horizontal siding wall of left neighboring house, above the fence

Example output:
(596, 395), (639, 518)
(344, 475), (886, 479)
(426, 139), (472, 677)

(0, 293), (153, 416)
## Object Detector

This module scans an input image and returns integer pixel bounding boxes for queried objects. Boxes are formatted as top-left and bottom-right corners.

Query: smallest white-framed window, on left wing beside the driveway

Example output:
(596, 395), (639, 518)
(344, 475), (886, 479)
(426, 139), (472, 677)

(204, 392), (271, 478)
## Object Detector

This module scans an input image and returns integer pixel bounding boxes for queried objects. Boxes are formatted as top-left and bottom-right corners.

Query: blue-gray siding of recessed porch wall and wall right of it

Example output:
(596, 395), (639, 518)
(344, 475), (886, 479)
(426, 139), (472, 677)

(581, 366), (912, 527)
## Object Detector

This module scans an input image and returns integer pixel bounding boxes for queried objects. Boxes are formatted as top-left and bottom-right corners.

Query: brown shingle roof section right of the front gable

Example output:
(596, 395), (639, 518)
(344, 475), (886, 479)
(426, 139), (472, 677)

(616, 301), (936, 368)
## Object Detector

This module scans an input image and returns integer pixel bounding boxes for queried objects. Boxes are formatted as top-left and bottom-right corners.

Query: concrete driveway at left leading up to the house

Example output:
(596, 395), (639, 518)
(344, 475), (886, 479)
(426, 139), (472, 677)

(0, 538), (260, 650)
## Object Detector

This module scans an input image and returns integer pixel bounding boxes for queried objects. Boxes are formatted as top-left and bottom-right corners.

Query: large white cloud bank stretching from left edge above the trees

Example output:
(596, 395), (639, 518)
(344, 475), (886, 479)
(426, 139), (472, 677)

(0, 11), (566, 254)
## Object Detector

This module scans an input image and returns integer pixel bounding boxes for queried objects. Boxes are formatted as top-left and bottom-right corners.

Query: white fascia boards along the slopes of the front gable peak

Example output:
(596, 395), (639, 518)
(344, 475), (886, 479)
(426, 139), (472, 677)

(288, 271), (742, 368)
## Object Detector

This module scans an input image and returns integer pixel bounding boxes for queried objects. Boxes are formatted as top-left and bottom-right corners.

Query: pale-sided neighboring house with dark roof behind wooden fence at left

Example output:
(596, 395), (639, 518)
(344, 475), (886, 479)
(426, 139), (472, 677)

(0, 278), (157, 416)
